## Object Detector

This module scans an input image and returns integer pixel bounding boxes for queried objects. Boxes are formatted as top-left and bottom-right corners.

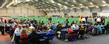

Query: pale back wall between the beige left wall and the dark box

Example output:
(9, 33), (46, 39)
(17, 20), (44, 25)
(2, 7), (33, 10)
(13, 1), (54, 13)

(47, 9), (92, 16)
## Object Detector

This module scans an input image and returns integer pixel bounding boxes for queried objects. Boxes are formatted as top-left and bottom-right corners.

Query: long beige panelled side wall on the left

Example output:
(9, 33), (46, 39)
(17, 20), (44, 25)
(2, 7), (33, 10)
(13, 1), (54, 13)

(0, 7), (44, 16)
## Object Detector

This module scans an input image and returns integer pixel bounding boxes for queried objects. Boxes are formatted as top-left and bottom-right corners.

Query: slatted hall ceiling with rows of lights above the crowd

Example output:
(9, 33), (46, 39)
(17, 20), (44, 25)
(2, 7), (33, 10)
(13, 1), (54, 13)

(0, 0), (109, 11)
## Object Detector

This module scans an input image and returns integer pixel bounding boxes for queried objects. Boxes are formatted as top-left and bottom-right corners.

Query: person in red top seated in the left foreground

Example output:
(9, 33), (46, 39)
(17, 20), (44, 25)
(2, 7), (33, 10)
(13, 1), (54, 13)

(20, 30), (28, 44)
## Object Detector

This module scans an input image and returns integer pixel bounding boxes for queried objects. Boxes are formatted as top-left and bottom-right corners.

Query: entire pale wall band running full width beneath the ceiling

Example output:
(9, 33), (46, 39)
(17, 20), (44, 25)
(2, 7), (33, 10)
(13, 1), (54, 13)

(0, 7), (109, 16)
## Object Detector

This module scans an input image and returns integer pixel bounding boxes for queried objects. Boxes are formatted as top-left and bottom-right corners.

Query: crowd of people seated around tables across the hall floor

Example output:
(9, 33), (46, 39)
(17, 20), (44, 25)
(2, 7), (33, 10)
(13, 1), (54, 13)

(0, 17), (109, 44)
